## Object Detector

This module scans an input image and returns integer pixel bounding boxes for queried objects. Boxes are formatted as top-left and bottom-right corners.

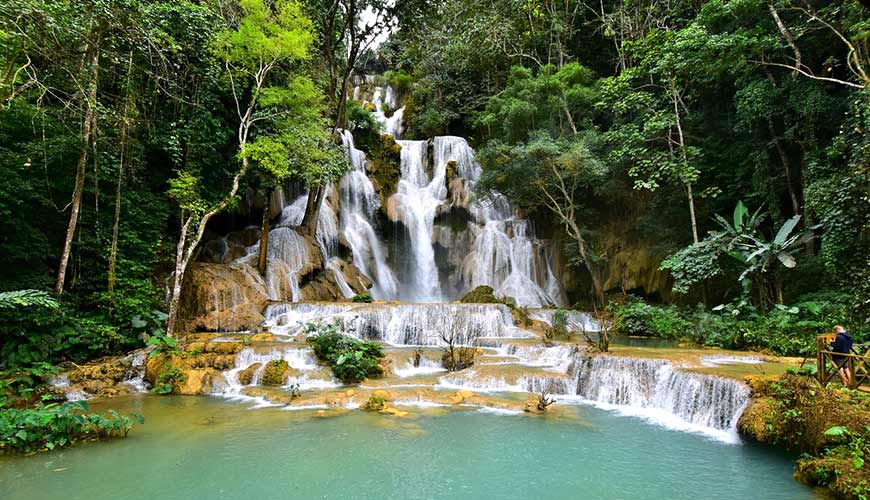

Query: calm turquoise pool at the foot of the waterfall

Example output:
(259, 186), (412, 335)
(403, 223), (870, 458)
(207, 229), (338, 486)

(0, 397), (816, 500)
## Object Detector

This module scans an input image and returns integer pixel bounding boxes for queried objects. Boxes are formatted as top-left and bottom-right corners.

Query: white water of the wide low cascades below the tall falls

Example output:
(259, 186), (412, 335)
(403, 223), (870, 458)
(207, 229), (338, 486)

(201, 296), (759, 443)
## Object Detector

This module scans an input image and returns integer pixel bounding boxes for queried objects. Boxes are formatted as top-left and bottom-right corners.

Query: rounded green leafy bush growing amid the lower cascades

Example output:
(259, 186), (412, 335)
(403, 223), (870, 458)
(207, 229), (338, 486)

(307, 323), (384, 384)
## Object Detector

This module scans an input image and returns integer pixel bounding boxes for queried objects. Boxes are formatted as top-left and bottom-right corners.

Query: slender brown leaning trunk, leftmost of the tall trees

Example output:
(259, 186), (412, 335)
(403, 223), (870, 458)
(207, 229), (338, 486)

(54, 44), (100, 297)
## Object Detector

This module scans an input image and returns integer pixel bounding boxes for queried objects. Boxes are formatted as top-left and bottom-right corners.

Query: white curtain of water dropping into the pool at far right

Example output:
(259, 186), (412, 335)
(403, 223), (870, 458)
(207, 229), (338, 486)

(574, 354), (749, 442)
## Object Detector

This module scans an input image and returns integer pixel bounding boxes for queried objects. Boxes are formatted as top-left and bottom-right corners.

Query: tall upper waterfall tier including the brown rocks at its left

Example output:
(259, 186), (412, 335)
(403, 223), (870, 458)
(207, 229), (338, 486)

(187, 77), (566, 320)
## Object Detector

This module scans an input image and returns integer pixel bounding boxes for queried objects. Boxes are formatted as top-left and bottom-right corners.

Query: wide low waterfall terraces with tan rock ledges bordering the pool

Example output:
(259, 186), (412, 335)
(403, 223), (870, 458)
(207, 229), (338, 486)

(58, 302), (761, 442)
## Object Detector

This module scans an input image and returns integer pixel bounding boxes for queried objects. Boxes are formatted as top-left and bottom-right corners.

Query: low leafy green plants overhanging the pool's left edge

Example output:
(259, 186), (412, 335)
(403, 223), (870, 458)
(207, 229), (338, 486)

(0, 401), (144, 452)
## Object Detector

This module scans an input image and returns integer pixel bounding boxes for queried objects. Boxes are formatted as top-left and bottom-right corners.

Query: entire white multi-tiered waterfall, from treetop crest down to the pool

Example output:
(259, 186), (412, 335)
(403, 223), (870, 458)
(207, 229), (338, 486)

(182, 73), (748, 441)
